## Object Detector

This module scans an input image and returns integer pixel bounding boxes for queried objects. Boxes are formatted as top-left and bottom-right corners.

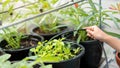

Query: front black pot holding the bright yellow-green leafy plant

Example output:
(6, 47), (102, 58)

(45, 42), (85, 68)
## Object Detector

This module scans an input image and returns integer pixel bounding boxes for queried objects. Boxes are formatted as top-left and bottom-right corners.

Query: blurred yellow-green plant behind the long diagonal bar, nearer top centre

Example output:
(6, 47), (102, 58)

(25, 0), (58, 16)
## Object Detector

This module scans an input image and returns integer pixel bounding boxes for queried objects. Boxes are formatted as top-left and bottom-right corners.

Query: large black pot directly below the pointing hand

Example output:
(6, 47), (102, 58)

(63, 31), (102, 68)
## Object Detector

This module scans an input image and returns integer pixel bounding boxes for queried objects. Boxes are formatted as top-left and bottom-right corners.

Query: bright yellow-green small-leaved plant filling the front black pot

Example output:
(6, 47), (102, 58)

(30, 39), (82, 62)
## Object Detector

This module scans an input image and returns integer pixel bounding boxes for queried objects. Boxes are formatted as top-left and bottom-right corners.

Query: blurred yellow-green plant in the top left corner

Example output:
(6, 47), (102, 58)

(0, 0), (20, 23)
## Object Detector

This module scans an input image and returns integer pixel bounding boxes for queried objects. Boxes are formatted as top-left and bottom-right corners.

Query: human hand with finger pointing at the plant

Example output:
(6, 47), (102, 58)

(85, 26), (108, 41)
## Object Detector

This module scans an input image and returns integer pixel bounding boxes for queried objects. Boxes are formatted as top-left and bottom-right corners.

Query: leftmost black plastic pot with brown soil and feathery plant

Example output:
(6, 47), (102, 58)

(0, 35), (43, 61)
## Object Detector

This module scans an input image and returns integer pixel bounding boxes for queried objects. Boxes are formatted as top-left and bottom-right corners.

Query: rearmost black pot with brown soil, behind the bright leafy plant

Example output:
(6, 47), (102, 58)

(31, 26), (68, 40)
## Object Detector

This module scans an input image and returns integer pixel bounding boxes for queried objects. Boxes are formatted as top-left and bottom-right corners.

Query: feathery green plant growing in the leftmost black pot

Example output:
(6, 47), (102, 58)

(1, 28), (25, 49)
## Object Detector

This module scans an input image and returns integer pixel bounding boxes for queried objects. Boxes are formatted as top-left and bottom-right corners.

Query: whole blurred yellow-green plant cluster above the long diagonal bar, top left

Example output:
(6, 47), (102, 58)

(0, 0), (58, 23)
